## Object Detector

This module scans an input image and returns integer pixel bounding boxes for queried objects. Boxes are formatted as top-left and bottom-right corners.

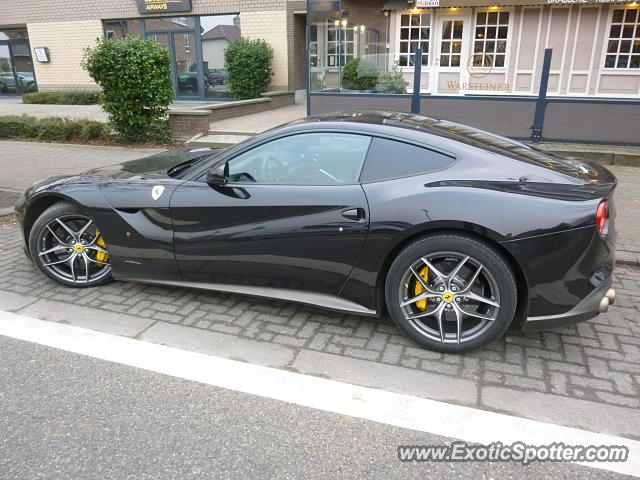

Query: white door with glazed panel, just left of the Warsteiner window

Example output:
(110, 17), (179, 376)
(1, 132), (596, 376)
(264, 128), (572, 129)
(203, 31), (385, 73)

(431, 15), (469, 95)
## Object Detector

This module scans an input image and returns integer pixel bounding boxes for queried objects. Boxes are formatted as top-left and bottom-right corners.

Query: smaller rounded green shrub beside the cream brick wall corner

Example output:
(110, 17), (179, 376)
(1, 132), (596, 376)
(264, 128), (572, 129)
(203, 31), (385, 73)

(224, 38), (273, 100)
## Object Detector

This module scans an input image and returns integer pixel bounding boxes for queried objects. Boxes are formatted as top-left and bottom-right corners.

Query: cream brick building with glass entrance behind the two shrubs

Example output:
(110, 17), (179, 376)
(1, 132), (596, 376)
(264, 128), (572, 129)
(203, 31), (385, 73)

(0, 0), (306, 99)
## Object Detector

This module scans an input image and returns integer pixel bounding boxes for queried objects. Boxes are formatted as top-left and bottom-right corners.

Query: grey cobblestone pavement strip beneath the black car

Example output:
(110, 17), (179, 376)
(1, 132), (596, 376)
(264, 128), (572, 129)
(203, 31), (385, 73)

(0, 224), (640, 416)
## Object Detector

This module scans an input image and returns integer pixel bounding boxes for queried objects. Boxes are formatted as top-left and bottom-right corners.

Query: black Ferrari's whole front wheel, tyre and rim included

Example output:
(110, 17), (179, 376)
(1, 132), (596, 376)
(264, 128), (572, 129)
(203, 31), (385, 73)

(29, 202), (111, 288)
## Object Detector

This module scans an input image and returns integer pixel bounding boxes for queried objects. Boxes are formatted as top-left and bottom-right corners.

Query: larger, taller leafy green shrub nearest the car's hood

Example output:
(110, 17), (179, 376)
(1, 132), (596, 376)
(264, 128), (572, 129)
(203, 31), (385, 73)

(82, 36), (175, 140)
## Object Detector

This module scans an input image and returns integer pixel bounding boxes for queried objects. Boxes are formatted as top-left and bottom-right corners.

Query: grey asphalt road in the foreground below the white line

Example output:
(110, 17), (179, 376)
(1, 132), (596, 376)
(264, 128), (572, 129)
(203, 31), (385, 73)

(0, 337), (625, 479)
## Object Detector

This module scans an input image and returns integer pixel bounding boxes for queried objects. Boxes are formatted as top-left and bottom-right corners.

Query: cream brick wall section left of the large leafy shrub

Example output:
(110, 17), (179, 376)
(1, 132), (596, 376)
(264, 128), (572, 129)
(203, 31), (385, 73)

(27, 20), (103, 92)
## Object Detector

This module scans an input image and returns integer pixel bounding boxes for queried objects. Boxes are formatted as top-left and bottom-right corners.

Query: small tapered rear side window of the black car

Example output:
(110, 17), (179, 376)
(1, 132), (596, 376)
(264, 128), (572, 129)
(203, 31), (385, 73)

(360, 138), (455, 183)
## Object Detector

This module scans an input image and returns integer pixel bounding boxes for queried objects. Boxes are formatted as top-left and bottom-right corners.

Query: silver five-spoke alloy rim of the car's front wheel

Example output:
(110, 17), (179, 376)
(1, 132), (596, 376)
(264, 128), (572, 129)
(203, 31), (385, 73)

(37, 214), (111, 284)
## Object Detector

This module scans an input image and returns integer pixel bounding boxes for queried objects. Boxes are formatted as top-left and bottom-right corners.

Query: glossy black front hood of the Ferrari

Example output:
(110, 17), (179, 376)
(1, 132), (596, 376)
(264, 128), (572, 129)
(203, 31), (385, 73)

(83, 148), (219, 179)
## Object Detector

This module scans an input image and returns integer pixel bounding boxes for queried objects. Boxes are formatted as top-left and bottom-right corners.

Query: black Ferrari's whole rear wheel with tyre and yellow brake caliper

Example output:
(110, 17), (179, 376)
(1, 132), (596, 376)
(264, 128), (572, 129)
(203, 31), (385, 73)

(385, 234), (517, 353)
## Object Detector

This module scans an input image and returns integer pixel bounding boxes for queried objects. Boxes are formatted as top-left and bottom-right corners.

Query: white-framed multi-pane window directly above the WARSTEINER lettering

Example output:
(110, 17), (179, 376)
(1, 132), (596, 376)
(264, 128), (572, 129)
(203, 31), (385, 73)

(473, 12), (509, 68)
